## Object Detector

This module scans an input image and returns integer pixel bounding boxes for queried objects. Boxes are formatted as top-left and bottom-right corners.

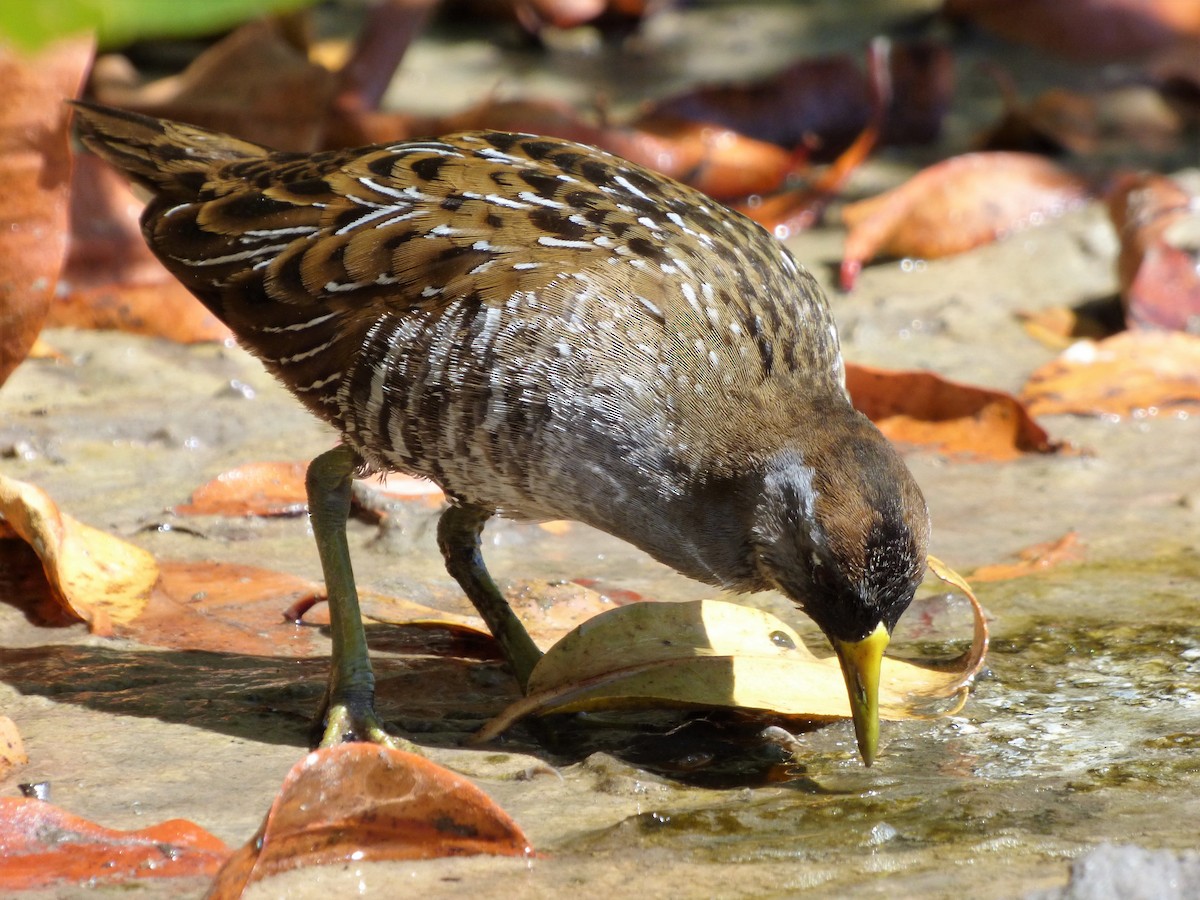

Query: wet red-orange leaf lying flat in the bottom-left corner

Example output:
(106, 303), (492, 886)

(0, 797), (229, 890)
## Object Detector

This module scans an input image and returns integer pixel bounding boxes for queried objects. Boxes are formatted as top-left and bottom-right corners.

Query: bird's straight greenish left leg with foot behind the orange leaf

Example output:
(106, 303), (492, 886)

(305, 446), (413, 750)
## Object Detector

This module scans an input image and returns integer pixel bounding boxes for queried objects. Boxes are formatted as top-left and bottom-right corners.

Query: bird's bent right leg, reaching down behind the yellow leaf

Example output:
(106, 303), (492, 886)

(438, 504), (541, 694)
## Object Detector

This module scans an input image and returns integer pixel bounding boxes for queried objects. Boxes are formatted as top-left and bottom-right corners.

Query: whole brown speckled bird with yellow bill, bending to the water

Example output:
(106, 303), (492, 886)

(74, 101), (930, 766)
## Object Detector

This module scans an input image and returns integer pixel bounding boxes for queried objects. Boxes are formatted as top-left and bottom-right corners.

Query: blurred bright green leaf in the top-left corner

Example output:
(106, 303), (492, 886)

(0, 0), (314, 50)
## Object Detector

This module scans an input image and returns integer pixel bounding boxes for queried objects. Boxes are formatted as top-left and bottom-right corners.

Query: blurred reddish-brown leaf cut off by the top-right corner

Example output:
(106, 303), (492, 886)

(942, 0), (1200, 62)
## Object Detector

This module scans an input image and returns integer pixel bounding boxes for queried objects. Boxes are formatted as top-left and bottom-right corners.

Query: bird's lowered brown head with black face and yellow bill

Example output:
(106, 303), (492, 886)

(754, 413), (929, 766)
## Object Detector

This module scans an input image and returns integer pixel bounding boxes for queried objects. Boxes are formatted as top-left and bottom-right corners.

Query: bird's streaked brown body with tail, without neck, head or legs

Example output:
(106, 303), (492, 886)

(72, 107), (848, 542)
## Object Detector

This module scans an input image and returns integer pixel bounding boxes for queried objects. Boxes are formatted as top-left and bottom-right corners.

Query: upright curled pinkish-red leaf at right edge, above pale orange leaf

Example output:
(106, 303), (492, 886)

(1108, 174), (1200, 332)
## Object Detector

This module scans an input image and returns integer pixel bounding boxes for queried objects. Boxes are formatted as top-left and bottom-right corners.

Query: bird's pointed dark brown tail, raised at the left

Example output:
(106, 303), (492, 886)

(71, 101), (271, 200)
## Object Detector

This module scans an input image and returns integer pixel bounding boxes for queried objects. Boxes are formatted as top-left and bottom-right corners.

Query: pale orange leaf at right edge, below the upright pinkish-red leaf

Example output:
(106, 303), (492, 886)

(1021, 331), (1200, 419)
